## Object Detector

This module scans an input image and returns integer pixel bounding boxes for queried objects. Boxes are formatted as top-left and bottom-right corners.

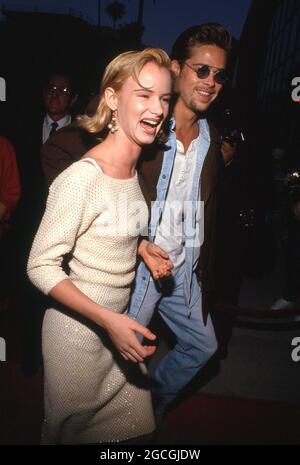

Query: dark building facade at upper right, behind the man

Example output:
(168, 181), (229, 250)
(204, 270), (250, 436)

(236, 0), (300, 158)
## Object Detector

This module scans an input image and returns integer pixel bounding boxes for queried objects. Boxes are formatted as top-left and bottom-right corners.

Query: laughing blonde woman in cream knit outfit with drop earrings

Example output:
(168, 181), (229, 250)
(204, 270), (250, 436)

(28, 48), (172, 444)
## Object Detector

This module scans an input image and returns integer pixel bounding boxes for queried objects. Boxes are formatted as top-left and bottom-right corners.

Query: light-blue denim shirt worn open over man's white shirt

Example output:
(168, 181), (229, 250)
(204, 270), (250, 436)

(128, 118), (210, 319)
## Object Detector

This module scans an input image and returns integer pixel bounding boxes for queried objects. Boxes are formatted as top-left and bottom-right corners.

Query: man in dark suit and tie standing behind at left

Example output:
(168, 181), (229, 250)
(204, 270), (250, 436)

(16, 71), (78, 374)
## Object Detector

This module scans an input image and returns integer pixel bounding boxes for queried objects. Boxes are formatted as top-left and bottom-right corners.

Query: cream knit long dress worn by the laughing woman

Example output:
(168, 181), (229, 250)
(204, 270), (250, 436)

(28, 158), (155, 444)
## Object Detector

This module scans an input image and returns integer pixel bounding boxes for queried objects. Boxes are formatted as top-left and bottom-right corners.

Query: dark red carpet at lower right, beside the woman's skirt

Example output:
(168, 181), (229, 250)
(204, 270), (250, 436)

(160, 395), (300, 445)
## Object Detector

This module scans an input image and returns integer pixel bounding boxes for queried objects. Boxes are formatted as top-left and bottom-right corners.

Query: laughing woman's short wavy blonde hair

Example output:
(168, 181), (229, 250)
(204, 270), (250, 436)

(77, 48), (171, 133)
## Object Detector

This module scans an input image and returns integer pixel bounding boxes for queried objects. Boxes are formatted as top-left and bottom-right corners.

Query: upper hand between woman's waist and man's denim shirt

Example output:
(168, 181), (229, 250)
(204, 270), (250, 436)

(138, 239), (173, 279)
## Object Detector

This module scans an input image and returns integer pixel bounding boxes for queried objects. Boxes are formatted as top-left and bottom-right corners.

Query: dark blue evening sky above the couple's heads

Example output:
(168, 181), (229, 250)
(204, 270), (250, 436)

(0, 0), (251, 52)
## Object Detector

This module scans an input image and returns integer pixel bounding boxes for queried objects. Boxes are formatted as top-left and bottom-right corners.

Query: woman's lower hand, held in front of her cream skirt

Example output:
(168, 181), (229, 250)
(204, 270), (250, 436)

(102, 311), (156, 363)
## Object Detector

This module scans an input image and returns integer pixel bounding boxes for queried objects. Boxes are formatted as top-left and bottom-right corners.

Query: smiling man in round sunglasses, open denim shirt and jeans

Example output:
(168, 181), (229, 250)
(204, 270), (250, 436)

(129, 23), (231, 416)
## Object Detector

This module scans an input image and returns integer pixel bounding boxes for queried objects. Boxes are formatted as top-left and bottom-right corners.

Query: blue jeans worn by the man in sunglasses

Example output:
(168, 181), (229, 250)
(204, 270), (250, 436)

(129, 266), (217, 414)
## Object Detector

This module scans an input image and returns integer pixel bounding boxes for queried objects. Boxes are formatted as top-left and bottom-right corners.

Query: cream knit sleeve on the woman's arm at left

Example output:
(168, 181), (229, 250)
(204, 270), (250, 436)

(27, 164), (89, 294)
